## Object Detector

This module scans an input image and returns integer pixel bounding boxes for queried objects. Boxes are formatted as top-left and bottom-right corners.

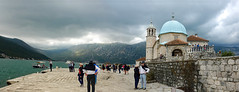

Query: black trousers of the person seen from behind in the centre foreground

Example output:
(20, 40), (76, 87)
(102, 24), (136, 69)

(87, 74), (95, 92)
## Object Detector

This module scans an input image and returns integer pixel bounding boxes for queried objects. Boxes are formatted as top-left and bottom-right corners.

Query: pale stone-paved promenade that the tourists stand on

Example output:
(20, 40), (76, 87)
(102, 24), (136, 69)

(0, 68), (184, 92)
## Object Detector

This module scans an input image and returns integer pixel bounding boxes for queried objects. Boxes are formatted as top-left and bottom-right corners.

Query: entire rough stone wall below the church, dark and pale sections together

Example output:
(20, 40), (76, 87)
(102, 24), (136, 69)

(148, 56), (239, 92)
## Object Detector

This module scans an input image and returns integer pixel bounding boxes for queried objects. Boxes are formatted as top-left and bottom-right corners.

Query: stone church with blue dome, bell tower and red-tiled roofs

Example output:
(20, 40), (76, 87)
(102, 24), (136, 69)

(146, 16), (216, 62)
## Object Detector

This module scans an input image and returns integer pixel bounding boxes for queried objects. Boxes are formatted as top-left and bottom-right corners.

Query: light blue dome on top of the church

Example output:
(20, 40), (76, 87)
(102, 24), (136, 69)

(159, 20), (187, 35)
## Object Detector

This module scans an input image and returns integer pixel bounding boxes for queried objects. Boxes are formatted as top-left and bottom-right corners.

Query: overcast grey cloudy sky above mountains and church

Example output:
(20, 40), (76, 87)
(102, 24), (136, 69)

(0, 0), (239, 49)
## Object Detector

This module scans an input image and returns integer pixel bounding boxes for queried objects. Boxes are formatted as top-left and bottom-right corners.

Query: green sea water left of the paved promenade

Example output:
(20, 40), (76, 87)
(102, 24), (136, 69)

(0, 59), (68, 88)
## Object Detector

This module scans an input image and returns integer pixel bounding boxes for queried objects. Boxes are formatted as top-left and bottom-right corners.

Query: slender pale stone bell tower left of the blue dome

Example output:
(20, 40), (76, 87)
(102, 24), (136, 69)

(146, 21), (156, 62)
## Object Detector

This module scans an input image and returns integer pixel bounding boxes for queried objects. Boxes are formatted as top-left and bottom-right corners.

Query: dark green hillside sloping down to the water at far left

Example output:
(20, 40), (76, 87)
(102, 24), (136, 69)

(0, 36), (50, 60)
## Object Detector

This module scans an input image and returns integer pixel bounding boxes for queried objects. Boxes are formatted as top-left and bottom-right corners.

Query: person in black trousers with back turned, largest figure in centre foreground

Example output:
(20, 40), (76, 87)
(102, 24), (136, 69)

(85, 61), (100, 92)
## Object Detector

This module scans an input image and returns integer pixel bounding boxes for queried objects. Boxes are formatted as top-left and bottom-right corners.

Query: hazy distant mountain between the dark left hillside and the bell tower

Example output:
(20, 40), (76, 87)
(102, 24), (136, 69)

(41, 42), (146, 64)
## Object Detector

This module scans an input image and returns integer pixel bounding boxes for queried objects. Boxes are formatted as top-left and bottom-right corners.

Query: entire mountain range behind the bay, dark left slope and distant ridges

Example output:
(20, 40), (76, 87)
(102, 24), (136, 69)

(0, 36), (239, 64)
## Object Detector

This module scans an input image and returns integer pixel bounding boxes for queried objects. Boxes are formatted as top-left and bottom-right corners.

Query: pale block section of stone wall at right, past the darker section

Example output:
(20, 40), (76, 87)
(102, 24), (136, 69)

(196, 57), (239, 92)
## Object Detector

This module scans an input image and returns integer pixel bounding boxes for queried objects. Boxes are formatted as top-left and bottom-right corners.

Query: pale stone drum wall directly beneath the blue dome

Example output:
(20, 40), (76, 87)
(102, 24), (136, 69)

(159, 33), (187, 43)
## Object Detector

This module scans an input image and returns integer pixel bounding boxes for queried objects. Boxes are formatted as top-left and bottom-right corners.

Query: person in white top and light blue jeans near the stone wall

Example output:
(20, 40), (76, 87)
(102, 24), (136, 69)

(139, 61), (150, 90)
